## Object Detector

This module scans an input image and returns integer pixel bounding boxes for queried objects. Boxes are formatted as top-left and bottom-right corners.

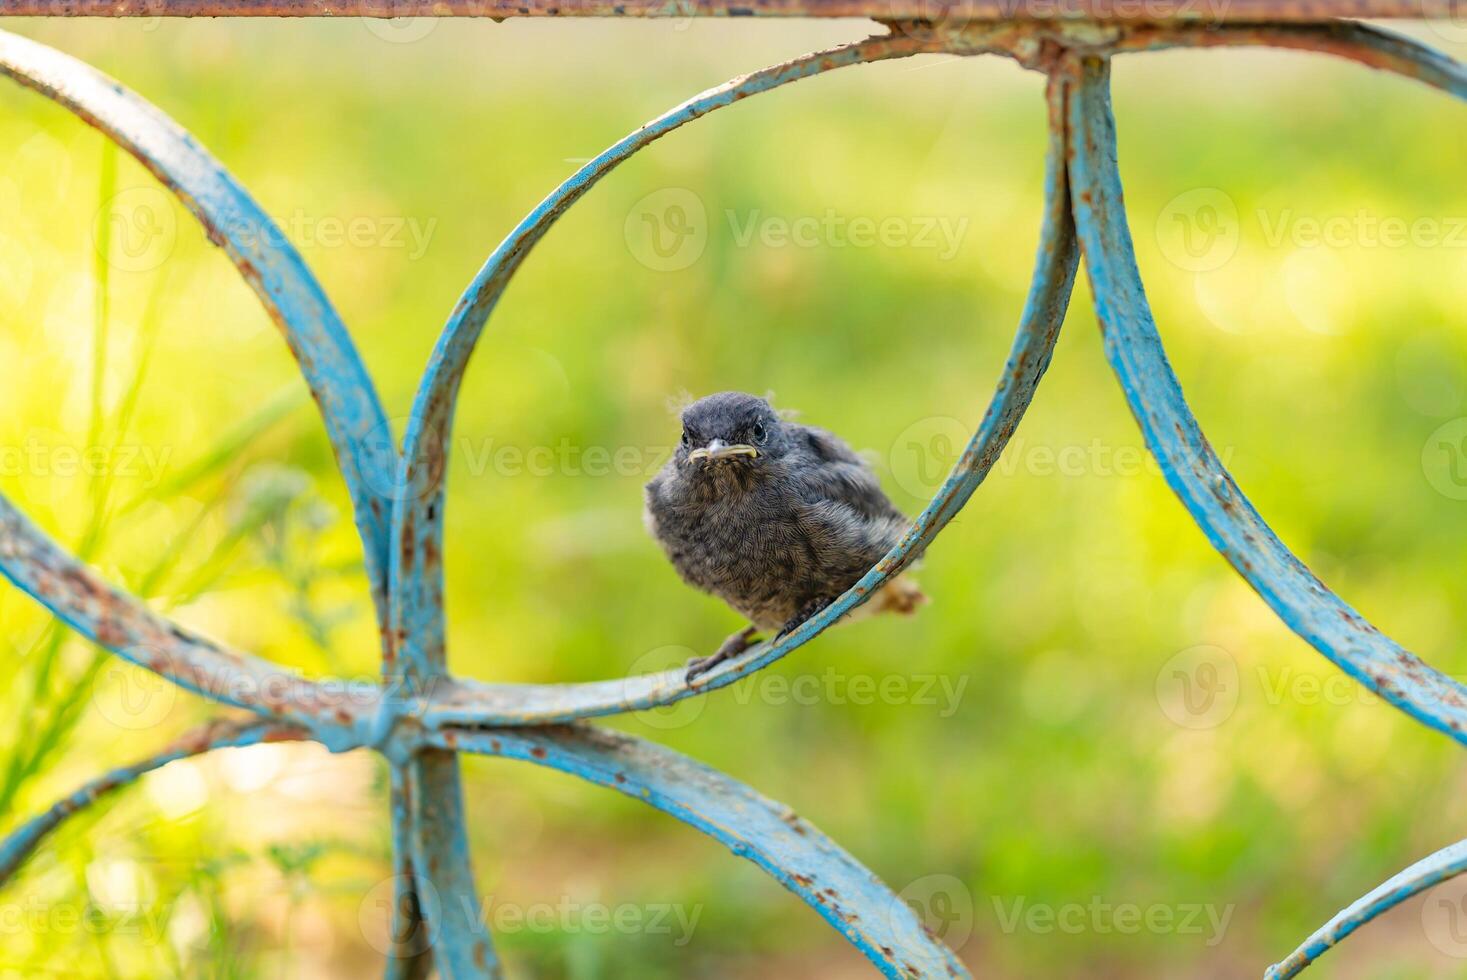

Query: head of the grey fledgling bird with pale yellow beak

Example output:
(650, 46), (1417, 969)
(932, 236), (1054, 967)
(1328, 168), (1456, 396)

(676, 392), (788, 475)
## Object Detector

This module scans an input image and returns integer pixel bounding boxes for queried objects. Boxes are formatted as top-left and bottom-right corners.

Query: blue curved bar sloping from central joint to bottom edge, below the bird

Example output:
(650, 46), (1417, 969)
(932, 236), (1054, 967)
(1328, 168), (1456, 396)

(428, 725), (968, 980)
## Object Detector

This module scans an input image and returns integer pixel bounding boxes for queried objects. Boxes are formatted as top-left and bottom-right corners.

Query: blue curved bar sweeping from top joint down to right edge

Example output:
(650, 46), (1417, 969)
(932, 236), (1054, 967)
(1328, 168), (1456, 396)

(1069, 47), (1467, 742)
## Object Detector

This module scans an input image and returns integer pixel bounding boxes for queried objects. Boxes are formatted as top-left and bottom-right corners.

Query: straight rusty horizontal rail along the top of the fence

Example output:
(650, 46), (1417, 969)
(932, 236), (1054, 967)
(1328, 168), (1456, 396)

(0, 0), (1467, 23)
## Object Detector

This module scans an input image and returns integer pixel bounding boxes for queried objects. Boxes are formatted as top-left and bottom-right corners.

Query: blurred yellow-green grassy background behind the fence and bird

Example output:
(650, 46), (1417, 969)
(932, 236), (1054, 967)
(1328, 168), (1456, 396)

(0, 19), (1467, 980)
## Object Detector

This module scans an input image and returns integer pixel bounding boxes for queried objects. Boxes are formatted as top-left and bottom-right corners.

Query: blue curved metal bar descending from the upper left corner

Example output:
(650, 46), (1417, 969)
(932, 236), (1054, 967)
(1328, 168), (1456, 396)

(0, 31), (396, 624)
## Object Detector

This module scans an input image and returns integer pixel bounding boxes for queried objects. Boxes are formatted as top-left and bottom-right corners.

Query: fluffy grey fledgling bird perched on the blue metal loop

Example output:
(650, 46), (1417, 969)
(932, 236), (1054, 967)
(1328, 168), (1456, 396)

(644, 392), (926, 681)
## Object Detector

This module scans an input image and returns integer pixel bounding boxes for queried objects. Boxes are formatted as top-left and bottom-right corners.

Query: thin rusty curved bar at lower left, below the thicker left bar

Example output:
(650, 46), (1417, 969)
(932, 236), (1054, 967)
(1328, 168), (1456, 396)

(0, 717), (310, 886)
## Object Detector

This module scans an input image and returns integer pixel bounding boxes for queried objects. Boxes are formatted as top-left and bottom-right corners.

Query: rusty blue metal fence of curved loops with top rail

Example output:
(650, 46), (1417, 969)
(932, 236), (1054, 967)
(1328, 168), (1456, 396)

(0, 0), (1467, 977)
